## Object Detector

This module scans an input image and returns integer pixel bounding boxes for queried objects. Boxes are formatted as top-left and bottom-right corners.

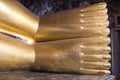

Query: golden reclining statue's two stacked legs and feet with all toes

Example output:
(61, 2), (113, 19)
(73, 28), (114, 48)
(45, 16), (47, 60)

(0, 0), (111, 75)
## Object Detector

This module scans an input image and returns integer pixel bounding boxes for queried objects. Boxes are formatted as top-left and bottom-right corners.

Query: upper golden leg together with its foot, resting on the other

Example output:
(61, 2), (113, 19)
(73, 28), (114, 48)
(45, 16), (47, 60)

(0, 0), (109, 43)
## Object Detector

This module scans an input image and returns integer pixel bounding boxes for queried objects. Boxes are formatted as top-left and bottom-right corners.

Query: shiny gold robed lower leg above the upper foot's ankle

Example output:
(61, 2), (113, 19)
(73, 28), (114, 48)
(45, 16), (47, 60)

(0, 0), (39, 43)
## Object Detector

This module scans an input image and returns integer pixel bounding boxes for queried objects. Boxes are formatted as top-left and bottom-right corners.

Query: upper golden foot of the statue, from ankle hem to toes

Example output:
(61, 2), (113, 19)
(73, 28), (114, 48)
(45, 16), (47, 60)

(35, 3), (110, 41)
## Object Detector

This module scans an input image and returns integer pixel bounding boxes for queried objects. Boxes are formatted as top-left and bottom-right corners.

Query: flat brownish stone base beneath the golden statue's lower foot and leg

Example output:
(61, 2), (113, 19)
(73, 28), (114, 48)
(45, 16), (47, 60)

(0, 71), (116, 80)
